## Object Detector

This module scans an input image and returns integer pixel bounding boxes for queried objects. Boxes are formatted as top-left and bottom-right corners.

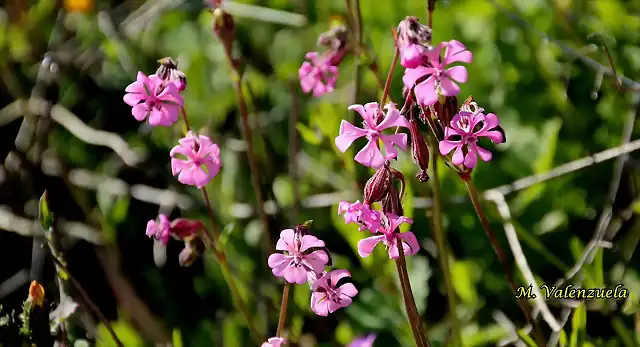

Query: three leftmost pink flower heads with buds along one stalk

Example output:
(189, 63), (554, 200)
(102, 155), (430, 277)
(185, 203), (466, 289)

(123, 58), (222, 266)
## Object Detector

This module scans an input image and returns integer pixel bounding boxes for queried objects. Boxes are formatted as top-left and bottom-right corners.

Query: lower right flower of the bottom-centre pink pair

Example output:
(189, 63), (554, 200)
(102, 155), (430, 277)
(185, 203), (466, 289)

(311, 270), (358, 317)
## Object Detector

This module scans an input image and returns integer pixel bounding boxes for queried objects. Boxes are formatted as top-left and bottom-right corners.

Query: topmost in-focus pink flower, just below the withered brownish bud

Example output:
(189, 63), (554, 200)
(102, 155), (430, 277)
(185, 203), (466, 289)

(402, 40), (473, 106)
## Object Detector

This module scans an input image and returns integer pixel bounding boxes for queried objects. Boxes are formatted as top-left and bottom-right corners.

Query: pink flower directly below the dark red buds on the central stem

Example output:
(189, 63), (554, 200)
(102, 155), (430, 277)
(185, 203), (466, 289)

(358, 214), (420, 259)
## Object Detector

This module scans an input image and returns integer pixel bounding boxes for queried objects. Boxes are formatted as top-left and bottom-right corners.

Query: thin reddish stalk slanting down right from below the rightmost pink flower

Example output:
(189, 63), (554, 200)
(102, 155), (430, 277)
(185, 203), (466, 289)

(464, 179), (546, 346)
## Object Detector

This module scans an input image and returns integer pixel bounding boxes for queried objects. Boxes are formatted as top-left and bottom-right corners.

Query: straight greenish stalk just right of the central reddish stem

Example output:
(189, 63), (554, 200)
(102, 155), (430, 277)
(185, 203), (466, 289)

(429, 137), (462, 346)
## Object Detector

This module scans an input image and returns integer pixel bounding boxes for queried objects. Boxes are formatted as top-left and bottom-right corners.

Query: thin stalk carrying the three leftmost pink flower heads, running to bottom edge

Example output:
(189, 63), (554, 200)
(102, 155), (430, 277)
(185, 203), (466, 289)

(182, 107), (263, 344)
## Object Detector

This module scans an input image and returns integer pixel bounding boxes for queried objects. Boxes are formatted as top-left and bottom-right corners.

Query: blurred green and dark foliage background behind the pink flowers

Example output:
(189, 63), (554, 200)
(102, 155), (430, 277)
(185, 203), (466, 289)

(0, 0), (640, 347)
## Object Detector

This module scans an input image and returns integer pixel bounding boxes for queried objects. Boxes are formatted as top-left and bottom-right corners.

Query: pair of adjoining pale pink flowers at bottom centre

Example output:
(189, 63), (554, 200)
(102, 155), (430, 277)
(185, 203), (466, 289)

(268, 223), (358, 316)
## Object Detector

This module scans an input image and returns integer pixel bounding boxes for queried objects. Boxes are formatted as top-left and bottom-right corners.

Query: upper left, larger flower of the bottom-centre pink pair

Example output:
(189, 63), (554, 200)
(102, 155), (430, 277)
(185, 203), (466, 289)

(267, 229), (329, 284)
